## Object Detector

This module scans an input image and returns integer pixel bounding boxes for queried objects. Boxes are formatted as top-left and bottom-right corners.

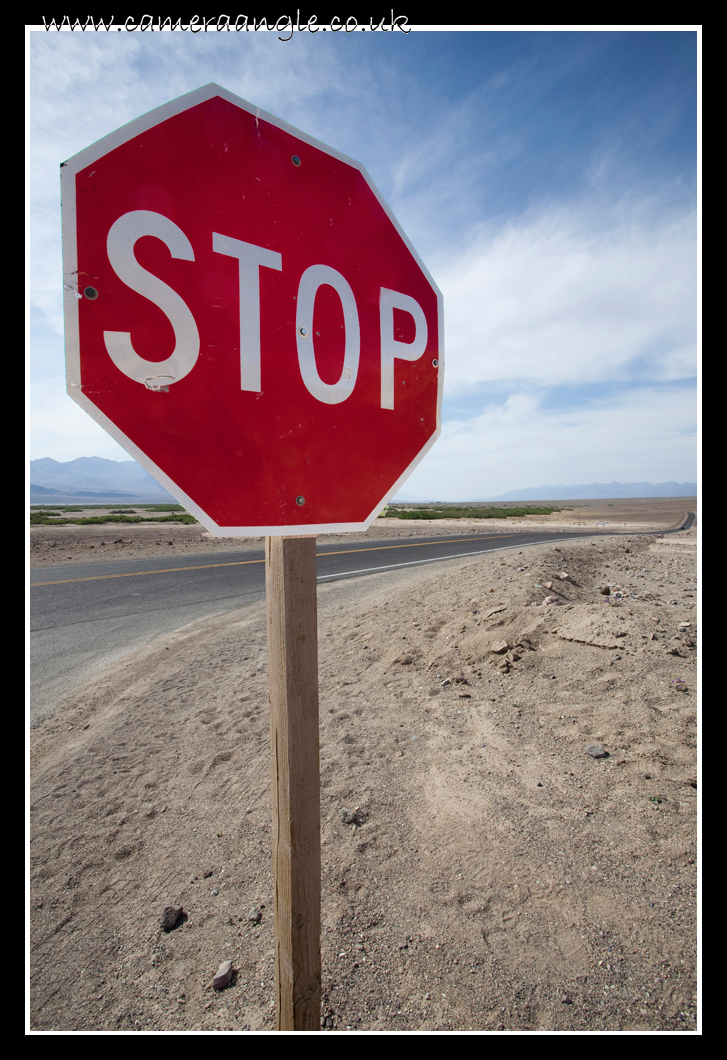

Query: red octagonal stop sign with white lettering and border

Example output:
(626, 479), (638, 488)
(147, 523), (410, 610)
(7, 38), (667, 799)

(61, 85), (443, 534)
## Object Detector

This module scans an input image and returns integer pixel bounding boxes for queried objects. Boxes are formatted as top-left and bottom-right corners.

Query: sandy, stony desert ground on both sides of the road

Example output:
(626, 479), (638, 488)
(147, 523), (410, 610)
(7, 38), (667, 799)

(29, 498), (699, 1034)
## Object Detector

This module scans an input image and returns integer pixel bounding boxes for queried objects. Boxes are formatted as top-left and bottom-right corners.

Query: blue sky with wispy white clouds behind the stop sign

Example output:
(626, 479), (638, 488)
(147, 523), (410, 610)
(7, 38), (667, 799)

(28, 28), (699, 499)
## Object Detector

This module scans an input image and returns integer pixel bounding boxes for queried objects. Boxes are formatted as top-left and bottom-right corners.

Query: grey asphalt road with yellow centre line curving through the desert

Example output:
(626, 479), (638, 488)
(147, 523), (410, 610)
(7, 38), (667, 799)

(30, 521), (694, 725)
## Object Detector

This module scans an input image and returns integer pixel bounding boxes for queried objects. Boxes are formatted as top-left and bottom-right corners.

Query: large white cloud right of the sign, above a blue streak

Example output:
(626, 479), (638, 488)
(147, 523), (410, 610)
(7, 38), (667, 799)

(437, 201), (696, 395)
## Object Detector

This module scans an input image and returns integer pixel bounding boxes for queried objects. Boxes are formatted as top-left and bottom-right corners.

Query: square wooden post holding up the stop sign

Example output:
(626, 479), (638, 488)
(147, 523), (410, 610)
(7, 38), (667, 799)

(265, 535), (321, 1030)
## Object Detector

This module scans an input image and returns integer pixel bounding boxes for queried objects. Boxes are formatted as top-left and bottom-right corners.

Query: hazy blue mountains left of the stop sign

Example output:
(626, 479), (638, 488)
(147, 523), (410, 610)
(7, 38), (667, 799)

(30, 457), (174, 505)
